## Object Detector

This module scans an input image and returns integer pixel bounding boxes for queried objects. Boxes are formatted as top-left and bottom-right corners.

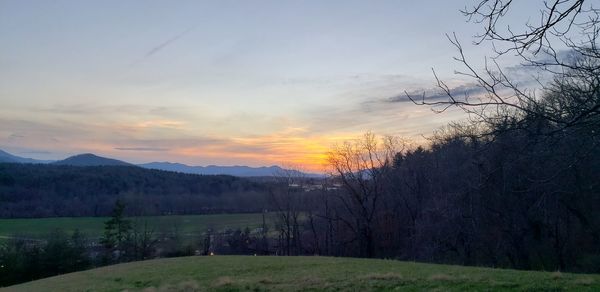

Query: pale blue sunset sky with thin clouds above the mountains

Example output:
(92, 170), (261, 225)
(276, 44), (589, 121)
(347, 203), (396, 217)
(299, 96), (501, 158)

(0, 0), (552, 171)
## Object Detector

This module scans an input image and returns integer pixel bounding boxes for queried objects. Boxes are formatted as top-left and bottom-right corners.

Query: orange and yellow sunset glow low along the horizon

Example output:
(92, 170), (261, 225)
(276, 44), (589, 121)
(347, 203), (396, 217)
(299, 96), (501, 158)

(35, 126), (396, 173)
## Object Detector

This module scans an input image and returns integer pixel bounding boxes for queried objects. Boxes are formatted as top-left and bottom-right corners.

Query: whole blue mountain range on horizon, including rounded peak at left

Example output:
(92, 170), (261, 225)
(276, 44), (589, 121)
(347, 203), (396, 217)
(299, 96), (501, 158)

(0, 150), (323, 178)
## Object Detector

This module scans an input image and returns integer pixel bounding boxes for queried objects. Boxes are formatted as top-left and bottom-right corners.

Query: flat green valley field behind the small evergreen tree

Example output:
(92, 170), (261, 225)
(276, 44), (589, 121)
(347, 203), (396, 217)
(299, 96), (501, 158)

(0, 213), (270, 239)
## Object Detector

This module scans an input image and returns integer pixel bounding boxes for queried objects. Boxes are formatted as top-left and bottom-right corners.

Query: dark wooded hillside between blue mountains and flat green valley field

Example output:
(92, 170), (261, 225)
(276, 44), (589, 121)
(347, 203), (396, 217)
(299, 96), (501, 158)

(0, 163), (266, 218)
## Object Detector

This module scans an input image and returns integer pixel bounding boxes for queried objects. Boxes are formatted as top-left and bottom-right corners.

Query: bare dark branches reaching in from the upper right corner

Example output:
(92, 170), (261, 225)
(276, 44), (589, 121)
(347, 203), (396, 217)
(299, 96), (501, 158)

(406, 0), (600, 134)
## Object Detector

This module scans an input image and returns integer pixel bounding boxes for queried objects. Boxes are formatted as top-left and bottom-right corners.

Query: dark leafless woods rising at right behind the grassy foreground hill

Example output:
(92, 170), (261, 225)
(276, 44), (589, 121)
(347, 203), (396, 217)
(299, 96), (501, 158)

(305, 114), (600, 272)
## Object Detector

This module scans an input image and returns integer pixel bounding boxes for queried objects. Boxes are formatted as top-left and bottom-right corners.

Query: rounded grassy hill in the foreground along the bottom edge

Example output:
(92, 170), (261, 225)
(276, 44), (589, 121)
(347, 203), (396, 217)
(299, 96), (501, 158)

(5, 256), (600, 291)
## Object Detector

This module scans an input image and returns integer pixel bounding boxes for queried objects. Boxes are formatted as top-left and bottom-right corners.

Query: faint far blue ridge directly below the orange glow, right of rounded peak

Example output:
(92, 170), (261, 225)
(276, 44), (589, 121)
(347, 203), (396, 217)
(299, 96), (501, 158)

(139, 162), (320, 177)
